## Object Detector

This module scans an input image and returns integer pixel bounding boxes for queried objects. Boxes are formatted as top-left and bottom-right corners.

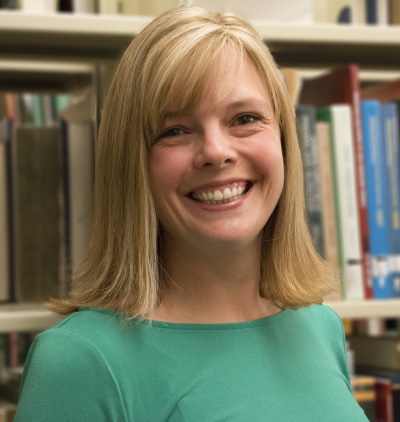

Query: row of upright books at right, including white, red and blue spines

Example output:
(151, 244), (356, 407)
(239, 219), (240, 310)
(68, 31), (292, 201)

(296, 65), (400, 299)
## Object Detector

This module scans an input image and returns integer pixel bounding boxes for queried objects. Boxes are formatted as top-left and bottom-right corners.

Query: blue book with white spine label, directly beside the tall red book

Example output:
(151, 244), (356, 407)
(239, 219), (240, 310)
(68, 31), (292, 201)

(361, 100), (392, 299)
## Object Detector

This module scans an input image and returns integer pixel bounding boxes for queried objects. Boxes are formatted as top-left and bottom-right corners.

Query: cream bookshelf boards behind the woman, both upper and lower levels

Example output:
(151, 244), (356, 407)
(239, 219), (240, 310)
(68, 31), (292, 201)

(0, 11), (400, 333)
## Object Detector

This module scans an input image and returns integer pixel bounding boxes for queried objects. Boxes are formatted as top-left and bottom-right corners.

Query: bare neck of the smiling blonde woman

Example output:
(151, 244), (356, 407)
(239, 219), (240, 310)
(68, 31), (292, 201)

(153, 237), (278, 323)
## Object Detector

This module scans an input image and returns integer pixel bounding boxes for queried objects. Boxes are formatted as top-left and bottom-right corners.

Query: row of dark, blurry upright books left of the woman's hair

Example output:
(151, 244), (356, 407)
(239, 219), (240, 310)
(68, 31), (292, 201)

(0, 91), (94, 303)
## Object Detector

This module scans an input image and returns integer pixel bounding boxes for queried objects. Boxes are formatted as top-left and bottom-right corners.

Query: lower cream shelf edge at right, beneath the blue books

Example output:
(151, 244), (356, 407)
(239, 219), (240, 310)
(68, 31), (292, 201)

(325, 299), (400, 319)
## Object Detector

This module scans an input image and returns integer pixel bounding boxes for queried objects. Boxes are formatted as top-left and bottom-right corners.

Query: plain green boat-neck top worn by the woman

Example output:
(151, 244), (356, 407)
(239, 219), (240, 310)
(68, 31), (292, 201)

(14, 305), (368, 422)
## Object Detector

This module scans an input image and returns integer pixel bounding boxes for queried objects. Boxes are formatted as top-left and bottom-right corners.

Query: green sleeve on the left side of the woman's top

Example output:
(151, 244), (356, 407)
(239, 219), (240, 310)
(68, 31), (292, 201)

(14, 328), (127, 422)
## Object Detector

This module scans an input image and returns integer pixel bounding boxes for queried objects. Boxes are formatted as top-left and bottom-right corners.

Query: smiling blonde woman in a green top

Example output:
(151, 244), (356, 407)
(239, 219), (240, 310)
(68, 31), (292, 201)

(16, 8), (367, 422)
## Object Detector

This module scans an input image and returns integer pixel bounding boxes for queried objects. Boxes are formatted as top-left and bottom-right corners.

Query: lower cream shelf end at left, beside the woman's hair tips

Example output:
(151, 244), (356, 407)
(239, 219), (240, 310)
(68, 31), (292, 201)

(0, 304), (64, 333)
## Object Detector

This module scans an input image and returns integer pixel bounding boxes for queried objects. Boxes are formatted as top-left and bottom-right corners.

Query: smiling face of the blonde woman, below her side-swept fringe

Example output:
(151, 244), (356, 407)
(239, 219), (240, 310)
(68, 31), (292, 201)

(149, 54), (284, 251)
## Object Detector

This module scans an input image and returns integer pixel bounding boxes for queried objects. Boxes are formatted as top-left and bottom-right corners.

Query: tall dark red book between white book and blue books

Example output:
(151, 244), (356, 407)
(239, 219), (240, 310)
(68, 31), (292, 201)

(299, 64), (373, 299)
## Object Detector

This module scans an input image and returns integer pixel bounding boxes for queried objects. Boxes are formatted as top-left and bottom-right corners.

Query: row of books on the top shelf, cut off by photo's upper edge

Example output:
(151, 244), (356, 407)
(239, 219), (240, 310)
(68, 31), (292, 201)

(0, 0), (400, 25)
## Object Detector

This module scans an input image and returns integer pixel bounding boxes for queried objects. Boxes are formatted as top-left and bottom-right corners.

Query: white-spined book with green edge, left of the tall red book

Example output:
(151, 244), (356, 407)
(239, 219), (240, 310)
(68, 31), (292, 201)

(317, 104), (364, 299)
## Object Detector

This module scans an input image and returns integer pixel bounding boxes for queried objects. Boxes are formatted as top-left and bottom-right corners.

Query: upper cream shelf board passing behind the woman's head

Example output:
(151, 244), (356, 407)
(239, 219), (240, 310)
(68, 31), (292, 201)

(0, 12), (400, 69)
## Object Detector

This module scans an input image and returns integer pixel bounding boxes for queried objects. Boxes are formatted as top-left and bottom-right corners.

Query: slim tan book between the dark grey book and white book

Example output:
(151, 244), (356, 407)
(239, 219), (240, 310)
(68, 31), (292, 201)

(316, 122), (341, 300)
